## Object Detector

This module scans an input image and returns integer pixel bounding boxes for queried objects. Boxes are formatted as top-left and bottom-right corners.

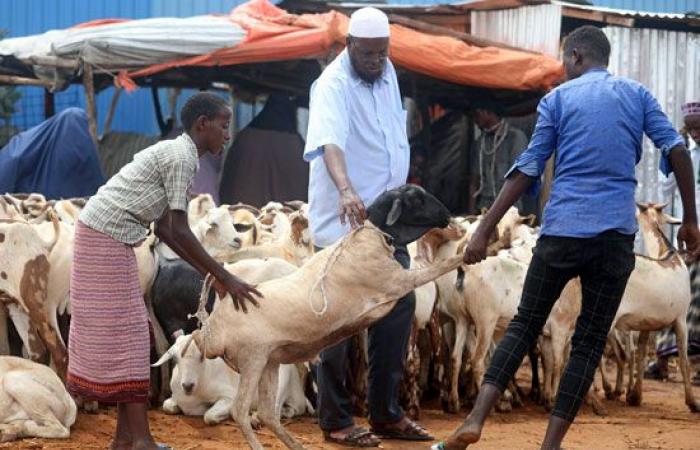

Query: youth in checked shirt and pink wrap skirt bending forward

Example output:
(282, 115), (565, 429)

(66, 92), (260, 450)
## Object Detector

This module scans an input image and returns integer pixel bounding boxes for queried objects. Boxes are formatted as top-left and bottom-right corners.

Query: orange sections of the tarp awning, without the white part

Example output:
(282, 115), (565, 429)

(119, 0), (564, 90)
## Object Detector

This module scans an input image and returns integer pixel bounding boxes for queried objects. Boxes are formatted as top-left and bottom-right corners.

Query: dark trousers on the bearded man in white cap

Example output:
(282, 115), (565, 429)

(317, 246), (416, 431)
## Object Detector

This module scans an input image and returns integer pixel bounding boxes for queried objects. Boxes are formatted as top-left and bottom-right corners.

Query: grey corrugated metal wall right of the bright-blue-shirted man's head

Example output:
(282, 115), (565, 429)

(604, 27), (700, 210)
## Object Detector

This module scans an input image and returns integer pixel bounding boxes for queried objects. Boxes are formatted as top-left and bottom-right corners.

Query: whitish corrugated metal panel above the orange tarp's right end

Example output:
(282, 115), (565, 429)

(471, 5), (561, 58)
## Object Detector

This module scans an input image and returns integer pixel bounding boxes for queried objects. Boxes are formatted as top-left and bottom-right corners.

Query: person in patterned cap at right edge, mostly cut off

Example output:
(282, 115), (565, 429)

(645, 102), (700, 385)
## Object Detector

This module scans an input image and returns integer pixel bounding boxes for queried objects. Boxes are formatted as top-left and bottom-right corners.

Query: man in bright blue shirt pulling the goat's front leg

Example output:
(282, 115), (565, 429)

(435, 26), (700, 450)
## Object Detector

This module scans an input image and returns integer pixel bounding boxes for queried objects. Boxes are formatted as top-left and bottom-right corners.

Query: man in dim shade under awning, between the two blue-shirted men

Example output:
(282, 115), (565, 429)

(468, 105), (527, 212)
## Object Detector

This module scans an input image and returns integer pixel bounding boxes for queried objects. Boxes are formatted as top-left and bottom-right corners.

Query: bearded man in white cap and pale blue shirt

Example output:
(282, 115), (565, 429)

(304, 8), (432, 447)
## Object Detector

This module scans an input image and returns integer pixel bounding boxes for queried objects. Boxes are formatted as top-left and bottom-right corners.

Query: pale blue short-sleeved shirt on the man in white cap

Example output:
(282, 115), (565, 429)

(304, 50), (409, 247)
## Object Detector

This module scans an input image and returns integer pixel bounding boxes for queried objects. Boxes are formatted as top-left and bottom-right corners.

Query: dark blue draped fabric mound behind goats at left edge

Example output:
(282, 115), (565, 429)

(0, 108), (105, 199)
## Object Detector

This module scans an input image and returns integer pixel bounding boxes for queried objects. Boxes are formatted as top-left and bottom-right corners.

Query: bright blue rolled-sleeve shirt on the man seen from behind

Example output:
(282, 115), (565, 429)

(506, 69), (683, 238)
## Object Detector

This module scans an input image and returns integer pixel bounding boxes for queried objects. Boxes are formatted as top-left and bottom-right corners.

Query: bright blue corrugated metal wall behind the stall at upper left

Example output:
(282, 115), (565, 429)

(0, 0), (256, 134)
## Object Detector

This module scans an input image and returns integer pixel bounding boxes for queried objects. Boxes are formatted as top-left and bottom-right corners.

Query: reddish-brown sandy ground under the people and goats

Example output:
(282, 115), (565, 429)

(0, 374), (700, 450)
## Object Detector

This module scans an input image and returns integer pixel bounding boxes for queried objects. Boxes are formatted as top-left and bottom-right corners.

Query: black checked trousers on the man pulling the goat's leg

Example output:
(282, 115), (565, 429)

(484, 231), (635, 422)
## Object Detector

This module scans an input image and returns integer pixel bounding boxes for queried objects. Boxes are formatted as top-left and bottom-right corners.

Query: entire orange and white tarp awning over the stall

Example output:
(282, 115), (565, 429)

(0, 0), (563, 91)
